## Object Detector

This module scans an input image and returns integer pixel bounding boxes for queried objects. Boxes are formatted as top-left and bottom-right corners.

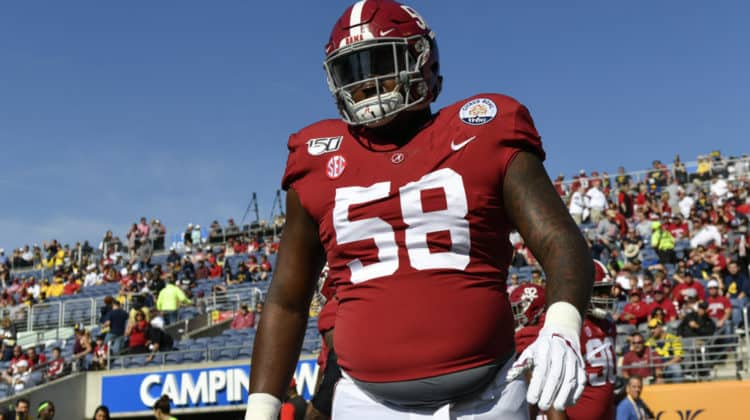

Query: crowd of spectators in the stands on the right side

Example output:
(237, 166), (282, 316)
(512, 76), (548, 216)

(509, 152), (750, 382)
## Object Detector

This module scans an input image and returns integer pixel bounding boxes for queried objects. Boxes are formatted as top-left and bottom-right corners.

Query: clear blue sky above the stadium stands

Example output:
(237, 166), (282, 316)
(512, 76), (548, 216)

(0, 0), (750, 249)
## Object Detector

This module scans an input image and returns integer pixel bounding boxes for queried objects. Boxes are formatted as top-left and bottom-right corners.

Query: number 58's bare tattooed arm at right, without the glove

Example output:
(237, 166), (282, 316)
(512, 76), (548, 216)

(503, 151), (594, 314)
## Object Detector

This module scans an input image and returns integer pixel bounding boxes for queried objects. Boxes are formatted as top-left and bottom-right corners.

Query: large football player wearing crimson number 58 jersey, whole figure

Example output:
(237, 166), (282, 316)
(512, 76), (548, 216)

(246, 0), (594, 420)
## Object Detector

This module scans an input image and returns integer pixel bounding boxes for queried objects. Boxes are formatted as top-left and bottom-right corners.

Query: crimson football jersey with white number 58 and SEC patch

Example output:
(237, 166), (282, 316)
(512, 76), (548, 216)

(282, 94), (544, 382)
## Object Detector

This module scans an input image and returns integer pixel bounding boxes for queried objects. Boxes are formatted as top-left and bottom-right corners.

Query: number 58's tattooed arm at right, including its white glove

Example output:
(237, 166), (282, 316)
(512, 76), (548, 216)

(503, 151), (594, 410)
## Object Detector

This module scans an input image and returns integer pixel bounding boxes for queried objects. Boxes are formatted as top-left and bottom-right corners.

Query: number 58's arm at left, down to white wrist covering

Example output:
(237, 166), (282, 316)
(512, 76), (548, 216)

(250, 189), (325, 420)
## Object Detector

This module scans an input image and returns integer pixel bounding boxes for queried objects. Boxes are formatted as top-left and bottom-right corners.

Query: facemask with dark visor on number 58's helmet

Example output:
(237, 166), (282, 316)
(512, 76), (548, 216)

(324, 35), (431, 127)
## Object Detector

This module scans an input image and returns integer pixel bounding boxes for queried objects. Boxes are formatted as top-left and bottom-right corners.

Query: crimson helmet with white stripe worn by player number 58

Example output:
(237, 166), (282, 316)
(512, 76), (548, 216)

(324, 0), (440, 127)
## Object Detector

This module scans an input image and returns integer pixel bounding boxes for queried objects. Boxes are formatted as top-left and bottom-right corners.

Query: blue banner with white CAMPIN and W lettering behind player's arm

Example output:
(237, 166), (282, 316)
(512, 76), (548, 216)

(101, 359), (318, 414)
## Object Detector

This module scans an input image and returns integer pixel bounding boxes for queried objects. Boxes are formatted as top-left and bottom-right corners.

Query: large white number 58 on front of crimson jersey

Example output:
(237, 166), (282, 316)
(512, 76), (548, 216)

(333, 168), (471, 283)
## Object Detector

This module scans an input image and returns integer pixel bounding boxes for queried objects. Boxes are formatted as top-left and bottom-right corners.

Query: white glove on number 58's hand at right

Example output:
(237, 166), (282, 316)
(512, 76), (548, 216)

(507, 302), (586, 410)
